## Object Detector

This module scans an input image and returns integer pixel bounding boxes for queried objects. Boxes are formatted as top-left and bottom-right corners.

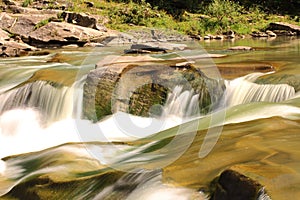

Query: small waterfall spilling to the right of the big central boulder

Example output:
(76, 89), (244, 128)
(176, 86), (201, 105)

(225, 73), (295, 107)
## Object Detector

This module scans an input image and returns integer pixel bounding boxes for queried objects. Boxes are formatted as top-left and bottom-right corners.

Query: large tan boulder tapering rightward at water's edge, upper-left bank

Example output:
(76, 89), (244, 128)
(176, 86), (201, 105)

(29, 22), (111, 47)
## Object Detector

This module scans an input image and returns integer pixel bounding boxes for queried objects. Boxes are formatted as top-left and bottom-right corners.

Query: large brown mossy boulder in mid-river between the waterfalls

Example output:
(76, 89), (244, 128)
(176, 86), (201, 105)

(83, 56), (224, 121)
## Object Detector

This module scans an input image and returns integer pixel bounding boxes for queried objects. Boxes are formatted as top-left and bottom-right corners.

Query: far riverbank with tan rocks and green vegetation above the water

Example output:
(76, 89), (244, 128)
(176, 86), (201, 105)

(0, 0), (300, 57)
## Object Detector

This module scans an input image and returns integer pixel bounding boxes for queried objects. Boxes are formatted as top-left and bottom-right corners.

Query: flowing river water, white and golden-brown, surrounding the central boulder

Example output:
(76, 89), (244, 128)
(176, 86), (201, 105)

(0, 39), (300, 200)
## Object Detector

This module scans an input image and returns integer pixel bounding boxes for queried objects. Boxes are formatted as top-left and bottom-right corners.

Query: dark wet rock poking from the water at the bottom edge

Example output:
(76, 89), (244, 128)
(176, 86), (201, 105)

(210, 170), (269, 200)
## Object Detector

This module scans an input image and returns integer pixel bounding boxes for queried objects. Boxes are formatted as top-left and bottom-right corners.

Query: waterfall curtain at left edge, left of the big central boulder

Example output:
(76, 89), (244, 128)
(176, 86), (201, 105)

(0, 77), (85, 122)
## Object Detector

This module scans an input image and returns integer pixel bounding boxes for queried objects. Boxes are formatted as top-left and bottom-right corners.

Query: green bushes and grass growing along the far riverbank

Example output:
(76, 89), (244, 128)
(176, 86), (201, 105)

(49, 0), (300, 35)
